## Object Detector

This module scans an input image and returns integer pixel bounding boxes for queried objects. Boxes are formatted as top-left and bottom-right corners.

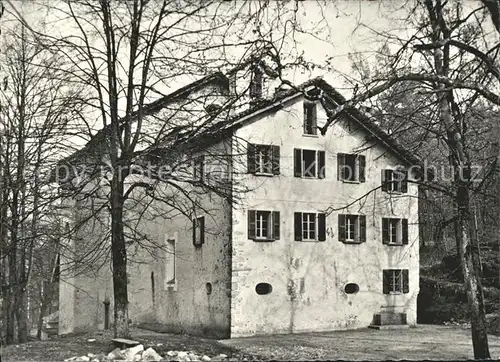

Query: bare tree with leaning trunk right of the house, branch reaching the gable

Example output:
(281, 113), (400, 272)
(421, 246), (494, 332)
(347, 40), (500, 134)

(302, 0), (500, 359)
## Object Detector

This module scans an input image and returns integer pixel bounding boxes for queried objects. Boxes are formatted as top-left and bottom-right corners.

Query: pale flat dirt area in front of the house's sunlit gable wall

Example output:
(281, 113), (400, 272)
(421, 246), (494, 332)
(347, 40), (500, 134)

(221, 325), (500, 360)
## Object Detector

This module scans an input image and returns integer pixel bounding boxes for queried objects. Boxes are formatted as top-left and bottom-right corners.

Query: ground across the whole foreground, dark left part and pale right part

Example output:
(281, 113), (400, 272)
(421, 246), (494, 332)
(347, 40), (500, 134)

(2, 325), (500, 362)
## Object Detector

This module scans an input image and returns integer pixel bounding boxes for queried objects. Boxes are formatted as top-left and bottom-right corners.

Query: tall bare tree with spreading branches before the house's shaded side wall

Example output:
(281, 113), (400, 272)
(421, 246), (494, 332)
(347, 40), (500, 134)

(9, 0), (306, 336)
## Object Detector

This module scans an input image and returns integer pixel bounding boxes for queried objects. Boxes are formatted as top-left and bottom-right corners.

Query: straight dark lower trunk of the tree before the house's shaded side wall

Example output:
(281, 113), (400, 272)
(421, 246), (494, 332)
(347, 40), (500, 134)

(111, 176), (130, 337)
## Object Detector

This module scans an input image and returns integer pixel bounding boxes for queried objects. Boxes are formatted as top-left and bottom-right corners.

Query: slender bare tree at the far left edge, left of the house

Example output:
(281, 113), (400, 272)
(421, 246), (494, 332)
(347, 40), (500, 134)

(0, 17), (84, 343)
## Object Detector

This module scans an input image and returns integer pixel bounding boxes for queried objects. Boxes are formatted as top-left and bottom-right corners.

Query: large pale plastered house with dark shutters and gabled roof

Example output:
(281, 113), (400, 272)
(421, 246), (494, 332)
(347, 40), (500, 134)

(59, 63), (419, 338)
